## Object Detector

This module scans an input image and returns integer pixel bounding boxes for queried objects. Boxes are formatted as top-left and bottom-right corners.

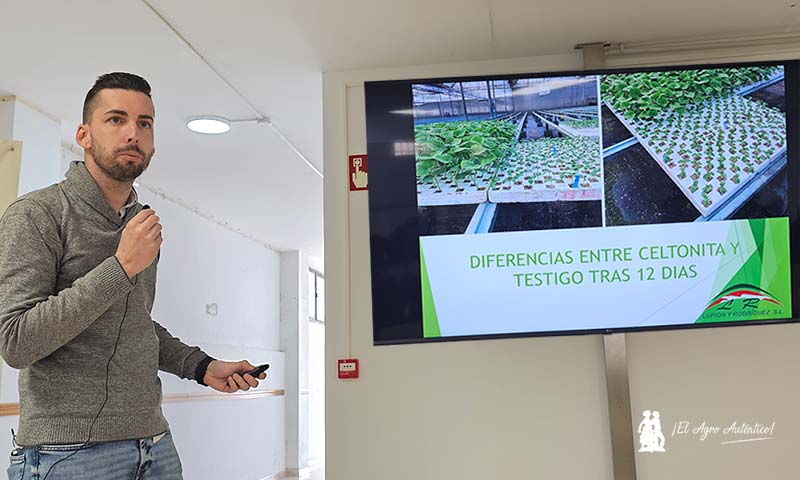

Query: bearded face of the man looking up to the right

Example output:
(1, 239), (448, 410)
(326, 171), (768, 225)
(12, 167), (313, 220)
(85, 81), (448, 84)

(82, 89), (155, 183)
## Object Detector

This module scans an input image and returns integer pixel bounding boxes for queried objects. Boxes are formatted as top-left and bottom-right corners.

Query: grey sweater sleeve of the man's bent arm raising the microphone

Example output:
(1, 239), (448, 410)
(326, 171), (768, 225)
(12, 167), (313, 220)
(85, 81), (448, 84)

(0, 200), (133, 368)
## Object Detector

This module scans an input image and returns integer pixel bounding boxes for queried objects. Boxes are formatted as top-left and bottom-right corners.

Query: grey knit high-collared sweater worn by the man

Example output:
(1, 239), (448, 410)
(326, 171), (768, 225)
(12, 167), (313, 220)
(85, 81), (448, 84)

(0, 162), (206, 445)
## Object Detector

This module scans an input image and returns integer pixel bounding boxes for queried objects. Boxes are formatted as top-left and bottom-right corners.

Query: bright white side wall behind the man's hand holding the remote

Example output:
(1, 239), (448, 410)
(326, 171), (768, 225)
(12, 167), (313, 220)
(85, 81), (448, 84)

(138, 187), (286, 480)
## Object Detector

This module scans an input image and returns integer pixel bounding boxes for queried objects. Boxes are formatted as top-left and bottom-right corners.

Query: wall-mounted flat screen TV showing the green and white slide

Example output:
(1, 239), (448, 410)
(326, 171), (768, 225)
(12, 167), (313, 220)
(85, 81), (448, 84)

(365, 61), (800, 344)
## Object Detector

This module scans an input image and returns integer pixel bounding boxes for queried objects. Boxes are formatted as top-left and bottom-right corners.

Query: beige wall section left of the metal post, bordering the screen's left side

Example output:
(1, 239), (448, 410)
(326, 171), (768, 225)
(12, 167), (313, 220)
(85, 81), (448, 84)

(323, 50), (613, 480)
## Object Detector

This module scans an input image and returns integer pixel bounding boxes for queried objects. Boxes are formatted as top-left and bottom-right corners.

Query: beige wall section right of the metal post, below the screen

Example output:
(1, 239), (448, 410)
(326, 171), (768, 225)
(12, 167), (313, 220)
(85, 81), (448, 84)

(627, 324), (800, 480)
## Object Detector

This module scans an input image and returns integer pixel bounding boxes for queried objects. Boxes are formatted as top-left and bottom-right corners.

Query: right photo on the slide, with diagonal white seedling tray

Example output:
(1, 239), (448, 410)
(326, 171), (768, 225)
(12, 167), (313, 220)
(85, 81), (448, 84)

(600, 66), (789, 226)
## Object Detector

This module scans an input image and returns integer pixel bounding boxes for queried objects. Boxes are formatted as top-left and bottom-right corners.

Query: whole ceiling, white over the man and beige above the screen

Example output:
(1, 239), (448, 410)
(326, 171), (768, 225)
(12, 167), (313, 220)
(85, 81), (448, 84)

(0, 0), (800, 258)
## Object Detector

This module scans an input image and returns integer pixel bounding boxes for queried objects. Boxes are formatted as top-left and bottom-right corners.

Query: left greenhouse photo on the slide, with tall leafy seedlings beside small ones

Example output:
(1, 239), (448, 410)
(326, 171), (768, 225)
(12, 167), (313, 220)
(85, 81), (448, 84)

(413, 76), (603, 235)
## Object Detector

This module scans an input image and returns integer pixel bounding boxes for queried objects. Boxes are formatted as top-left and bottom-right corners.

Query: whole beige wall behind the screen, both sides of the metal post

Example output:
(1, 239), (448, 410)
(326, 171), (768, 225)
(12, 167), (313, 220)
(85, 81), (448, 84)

(323, 45), (800, 480)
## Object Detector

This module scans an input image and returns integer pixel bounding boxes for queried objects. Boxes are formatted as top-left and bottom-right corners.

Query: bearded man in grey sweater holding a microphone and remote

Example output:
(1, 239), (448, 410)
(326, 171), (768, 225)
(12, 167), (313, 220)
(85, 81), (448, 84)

(0, 73), (266, 480)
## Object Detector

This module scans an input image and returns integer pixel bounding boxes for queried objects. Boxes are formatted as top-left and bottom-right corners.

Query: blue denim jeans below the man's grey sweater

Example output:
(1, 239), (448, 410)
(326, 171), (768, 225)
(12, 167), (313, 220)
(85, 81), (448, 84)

(8, 432), (183, 480)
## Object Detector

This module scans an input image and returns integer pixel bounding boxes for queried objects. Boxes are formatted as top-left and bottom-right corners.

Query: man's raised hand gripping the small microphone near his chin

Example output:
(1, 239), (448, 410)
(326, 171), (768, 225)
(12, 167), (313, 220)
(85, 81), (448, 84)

(115, 208), (163, 278)
